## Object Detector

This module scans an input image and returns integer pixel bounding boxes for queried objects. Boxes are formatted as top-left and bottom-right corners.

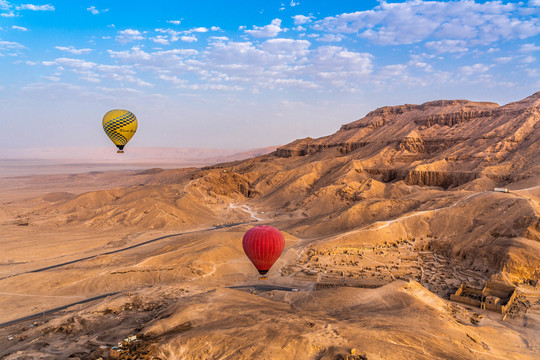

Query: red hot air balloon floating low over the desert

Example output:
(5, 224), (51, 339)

(242, 225), (285, 279)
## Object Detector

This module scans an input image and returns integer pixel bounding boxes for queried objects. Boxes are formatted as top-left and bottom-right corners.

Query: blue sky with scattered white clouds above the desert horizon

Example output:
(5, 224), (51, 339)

(0, 0), (540, 148)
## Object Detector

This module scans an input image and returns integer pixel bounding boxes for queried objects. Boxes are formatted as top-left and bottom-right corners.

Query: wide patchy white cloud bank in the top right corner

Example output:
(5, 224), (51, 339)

(313, 0), (540, 45)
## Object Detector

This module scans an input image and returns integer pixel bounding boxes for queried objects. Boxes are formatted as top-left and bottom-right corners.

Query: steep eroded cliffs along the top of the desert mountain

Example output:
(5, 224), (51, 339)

(275, 92), (540, 187)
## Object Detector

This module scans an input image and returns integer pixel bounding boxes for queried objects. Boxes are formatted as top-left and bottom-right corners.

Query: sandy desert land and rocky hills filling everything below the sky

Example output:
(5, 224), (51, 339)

(0, 93), (540, 359)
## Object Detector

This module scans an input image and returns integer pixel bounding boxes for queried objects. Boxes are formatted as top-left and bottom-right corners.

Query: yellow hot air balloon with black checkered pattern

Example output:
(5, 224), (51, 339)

(103, 109), (137, 153)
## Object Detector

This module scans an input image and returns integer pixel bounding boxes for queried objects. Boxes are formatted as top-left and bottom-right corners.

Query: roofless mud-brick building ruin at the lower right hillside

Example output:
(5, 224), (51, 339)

(450, 281), (517, 314)
